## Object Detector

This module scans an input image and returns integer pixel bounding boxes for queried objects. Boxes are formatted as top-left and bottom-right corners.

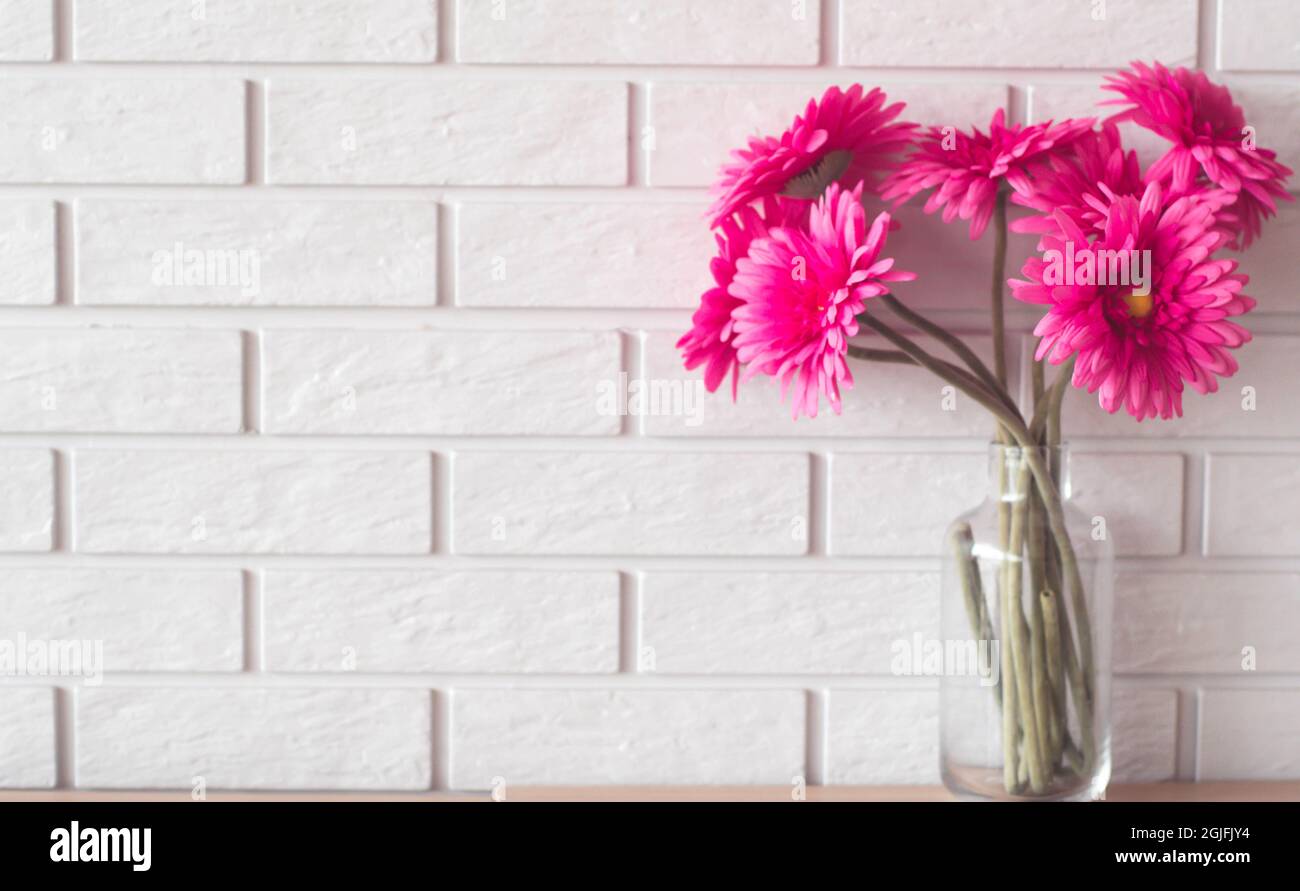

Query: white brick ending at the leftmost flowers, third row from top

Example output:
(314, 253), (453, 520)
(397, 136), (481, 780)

(456, 203), (714, 308)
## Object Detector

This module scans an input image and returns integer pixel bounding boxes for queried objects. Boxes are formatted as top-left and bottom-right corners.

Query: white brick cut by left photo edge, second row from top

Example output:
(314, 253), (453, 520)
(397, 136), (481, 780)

(0, 77), (244, 185)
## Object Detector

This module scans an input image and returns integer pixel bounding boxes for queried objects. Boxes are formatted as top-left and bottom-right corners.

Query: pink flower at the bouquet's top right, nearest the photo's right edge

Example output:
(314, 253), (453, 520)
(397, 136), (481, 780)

(1102, 62), (1291, 247)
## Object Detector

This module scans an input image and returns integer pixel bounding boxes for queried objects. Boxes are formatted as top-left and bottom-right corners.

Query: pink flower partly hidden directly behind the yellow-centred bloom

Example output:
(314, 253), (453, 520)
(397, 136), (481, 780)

(1010, 124), (1147, 234)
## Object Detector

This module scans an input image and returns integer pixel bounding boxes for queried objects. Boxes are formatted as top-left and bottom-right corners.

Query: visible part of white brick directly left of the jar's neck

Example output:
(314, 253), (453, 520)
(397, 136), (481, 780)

(831, 453), (988, 557)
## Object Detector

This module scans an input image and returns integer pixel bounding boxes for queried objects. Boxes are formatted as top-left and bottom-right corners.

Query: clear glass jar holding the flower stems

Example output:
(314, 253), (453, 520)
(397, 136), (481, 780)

(940, 444), (1114, 800)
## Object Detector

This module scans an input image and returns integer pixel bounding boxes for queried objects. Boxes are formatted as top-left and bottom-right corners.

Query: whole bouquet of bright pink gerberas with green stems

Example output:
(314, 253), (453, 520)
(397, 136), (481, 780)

(677, 62), (1291, 793)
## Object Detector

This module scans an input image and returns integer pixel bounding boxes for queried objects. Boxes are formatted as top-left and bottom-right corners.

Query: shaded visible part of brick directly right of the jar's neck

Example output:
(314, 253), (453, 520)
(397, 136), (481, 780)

(1070, 453), (1184, 557)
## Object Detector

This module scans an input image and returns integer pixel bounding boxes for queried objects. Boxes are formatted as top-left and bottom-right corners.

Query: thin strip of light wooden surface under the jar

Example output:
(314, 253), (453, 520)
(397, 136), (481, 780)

(0, 782), (1300, 803)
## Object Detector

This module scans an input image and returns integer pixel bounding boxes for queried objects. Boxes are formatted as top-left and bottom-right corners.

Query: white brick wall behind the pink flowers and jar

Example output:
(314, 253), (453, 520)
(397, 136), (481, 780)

(0, 0), (1300, 790)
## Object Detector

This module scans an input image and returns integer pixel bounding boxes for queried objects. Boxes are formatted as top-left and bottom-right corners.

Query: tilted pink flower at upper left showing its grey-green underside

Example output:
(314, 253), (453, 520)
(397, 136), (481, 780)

(709, 83), (917, 226)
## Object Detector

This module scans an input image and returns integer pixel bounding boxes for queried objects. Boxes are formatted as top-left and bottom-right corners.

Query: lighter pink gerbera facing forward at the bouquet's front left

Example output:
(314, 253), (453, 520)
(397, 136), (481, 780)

(728, 183), (915, 419)
